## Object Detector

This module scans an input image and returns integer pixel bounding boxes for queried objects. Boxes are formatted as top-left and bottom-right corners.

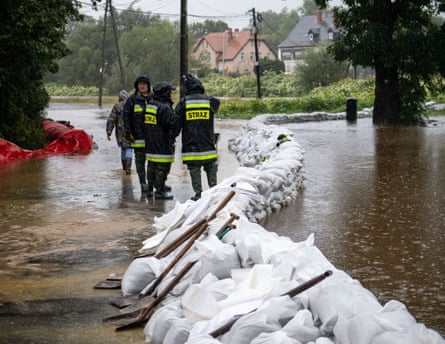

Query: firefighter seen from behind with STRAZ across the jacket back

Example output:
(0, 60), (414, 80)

(175, 74), (220, 200)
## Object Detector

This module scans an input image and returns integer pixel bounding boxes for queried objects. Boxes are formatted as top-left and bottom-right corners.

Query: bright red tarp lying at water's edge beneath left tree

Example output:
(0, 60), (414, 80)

(0, 119), (93, 164)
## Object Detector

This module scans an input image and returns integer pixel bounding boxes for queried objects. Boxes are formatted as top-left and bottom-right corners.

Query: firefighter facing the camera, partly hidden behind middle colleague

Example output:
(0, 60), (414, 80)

(124, 75), (151, 192)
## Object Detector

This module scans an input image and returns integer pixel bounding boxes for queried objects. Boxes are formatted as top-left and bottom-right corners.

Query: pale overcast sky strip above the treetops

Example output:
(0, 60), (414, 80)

(81, 0), (339, 29)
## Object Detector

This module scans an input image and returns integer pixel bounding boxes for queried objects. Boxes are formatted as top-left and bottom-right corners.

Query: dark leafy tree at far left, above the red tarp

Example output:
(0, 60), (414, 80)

(0, 0), (80, 148)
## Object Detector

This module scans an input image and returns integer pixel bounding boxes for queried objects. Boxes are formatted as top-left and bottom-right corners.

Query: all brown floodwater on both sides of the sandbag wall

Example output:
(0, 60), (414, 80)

(0, 104), (445, 343)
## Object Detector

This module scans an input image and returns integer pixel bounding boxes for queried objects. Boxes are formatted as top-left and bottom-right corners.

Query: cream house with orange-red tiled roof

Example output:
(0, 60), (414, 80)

(191, 29), (277, 74)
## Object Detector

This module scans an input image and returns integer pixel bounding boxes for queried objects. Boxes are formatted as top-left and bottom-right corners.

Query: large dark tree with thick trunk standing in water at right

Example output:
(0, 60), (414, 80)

(316, 0), (445, 124)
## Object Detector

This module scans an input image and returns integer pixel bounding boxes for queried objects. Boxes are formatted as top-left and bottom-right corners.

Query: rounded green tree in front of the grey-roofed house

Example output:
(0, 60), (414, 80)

(295, 46), (349, 92)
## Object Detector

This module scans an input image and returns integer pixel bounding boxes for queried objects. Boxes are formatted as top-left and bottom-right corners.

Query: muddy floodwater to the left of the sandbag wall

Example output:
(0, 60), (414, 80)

(0, 104), (242, 344)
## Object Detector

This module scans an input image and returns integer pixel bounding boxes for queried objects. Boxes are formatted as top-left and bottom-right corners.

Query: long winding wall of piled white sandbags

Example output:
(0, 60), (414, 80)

(116, 121), (445, 344)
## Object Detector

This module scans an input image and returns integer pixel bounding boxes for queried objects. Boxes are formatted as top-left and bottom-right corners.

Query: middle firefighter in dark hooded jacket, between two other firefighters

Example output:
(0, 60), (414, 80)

(144, 81), (176, 199)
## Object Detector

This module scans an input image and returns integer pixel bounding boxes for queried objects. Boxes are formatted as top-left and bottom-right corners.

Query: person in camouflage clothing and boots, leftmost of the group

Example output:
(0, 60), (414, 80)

(106, 90), (133, 175)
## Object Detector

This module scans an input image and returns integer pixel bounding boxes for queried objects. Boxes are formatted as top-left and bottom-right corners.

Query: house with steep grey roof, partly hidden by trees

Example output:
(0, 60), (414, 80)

(278, 10), (339, 73)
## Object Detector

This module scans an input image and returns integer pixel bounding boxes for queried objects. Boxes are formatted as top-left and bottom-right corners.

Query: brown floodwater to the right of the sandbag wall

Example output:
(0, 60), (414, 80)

(265, 119), (445, 334)
